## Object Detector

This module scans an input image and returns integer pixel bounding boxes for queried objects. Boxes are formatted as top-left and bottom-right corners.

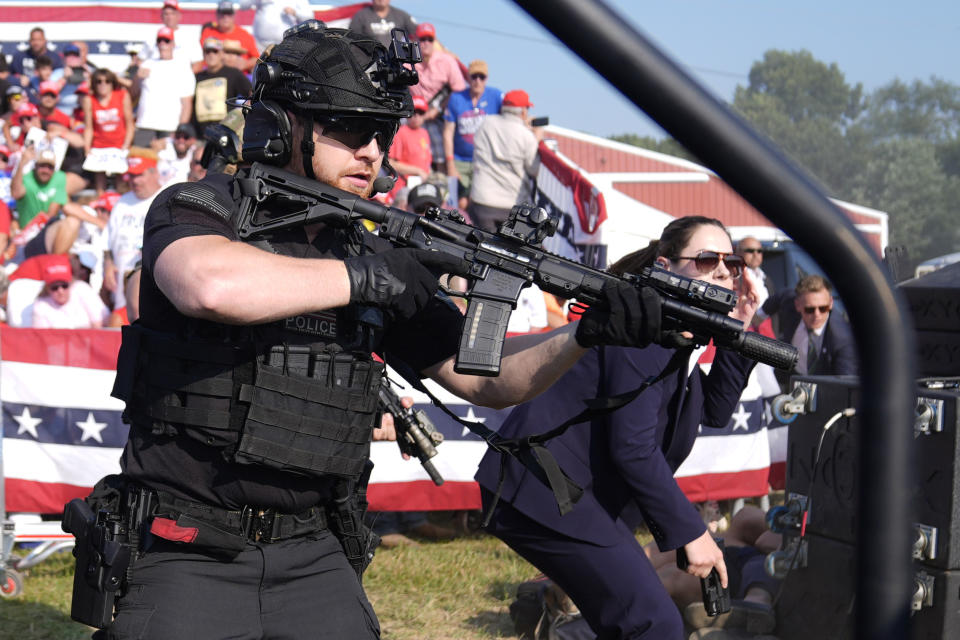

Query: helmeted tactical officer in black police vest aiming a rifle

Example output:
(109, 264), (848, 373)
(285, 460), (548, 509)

(86, 21), (659, 639)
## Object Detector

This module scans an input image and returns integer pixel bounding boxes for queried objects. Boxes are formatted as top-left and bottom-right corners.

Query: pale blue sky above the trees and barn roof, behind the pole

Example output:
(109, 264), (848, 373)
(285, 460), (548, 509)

(393, 0), (960, 137)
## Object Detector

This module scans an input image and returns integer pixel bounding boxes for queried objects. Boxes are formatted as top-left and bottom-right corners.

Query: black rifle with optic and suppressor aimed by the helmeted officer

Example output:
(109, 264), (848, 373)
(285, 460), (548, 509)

(234, 163), (798, 376)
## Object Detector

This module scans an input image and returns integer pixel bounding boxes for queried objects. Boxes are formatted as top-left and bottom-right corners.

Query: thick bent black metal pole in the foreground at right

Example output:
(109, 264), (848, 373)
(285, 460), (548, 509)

(516, 0), (915, 640)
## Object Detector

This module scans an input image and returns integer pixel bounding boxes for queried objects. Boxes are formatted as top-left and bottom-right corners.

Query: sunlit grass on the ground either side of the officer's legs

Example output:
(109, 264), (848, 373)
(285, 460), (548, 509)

(0, 524), (537, 640)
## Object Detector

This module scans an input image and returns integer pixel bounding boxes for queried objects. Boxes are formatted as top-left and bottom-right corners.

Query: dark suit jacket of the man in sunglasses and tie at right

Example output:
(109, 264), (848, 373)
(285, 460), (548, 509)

(763, 290), (857, 376)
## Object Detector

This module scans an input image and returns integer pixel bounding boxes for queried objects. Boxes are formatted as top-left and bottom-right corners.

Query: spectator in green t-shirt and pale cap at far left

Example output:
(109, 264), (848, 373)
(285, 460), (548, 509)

(10, 145), (67, 240)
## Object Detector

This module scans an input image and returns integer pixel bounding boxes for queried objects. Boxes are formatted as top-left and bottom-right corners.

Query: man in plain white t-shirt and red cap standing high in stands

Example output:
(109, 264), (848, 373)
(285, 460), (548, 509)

(133, 27), (196, 147)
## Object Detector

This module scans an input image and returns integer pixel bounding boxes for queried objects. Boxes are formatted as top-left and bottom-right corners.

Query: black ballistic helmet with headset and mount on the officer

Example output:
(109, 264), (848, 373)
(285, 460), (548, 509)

(243, 20), (421, 178)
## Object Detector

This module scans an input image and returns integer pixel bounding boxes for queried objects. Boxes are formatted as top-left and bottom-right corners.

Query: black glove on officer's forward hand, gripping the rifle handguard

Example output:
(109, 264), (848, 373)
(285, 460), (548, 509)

(575, 281), (661, 348)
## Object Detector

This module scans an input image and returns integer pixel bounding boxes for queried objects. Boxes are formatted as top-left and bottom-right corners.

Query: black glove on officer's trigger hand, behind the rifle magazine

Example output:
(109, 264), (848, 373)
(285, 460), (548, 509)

(343, 249), (465, 320)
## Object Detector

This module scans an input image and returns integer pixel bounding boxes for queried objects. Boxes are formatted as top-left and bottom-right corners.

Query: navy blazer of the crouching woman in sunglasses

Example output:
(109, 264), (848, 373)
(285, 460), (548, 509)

(476, 345), (754, 550)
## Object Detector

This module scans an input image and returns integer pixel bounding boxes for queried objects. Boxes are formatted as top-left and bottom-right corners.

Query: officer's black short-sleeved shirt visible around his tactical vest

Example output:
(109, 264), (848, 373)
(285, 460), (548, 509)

(121, 174), (462, 513)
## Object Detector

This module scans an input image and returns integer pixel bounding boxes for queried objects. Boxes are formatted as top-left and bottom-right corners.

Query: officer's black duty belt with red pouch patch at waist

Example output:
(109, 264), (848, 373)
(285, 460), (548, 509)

(150, 491), (327, 551)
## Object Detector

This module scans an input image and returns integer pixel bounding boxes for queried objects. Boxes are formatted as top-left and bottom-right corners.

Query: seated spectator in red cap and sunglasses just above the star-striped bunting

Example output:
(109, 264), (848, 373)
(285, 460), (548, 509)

(32, 256), (110, 329)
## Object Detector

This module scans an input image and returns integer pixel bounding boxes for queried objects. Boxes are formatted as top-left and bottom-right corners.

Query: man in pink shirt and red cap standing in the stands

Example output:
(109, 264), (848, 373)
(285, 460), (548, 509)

(410, 22), (467, 171)
